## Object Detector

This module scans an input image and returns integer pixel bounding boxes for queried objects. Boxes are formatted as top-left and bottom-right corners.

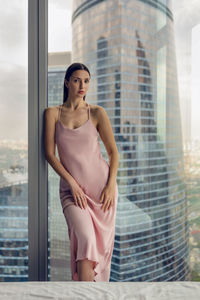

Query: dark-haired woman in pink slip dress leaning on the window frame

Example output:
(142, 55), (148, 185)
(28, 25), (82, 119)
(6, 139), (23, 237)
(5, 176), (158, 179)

(45, 63), (118, 281)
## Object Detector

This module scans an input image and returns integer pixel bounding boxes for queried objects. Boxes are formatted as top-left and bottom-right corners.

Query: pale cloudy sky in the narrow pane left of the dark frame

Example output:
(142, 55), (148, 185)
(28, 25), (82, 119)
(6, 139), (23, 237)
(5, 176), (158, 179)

(0, 0), (28, 141)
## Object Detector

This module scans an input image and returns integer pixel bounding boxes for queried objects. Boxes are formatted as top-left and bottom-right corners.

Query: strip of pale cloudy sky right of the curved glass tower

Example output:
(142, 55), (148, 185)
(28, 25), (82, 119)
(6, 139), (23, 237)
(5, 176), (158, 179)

(172, 0), (200, 140)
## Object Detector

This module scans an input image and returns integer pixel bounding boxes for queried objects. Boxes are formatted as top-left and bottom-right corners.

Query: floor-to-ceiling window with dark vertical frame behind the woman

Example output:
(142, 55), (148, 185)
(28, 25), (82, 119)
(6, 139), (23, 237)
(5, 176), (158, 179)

(0, 0), (200, 281)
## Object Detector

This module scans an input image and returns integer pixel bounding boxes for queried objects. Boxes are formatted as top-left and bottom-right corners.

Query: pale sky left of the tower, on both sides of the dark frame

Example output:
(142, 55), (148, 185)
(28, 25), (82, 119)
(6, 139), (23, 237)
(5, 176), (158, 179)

(0, 0), (72, 143)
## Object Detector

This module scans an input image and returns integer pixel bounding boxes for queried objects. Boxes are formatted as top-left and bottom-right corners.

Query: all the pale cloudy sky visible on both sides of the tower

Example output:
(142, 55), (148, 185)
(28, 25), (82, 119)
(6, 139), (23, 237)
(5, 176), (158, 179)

(0, 0), (200, 141)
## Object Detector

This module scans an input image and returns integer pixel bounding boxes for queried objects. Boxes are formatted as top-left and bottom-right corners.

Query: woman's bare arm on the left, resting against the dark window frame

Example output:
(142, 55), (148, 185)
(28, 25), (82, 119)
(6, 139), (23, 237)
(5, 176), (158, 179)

(44, 107), (74, 185)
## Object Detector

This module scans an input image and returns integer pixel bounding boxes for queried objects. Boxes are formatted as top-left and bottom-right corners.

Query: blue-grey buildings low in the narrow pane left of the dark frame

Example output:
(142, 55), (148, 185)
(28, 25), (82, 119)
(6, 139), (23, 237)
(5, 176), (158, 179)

(0, 166), (28, 282)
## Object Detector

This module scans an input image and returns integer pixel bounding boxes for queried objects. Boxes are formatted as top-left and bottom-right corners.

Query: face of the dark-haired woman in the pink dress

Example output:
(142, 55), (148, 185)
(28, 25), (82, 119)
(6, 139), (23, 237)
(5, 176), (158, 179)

(65, 70), (90, 98)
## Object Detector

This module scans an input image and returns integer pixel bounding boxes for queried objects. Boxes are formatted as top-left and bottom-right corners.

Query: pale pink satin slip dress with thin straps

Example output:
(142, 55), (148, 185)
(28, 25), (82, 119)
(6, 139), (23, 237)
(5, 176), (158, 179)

(55, 103), (118, 281)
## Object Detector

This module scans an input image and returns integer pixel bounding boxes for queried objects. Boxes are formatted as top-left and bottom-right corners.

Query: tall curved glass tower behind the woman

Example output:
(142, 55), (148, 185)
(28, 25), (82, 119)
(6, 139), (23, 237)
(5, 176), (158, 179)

(72, 0), (189, 281)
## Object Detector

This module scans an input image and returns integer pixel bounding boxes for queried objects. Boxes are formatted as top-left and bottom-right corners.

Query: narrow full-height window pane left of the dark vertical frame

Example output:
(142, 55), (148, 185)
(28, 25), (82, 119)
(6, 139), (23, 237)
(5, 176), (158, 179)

(0, 0), (29, 281)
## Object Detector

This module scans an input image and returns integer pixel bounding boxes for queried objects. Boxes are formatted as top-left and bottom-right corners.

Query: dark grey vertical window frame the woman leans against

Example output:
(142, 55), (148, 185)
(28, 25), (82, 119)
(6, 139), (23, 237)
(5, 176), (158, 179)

(28, 0), (48, 281)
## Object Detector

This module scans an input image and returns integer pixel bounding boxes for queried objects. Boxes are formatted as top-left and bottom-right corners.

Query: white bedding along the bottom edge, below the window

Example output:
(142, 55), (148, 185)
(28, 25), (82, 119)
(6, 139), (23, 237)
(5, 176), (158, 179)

(0, 281), (200, 300)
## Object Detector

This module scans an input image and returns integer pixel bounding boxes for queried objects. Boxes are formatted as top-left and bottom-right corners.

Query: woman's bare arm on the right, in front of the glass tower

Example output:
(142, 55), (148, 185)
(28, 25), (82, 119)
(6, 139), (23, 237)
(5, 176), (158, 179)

(96, 106), (119, 185)
